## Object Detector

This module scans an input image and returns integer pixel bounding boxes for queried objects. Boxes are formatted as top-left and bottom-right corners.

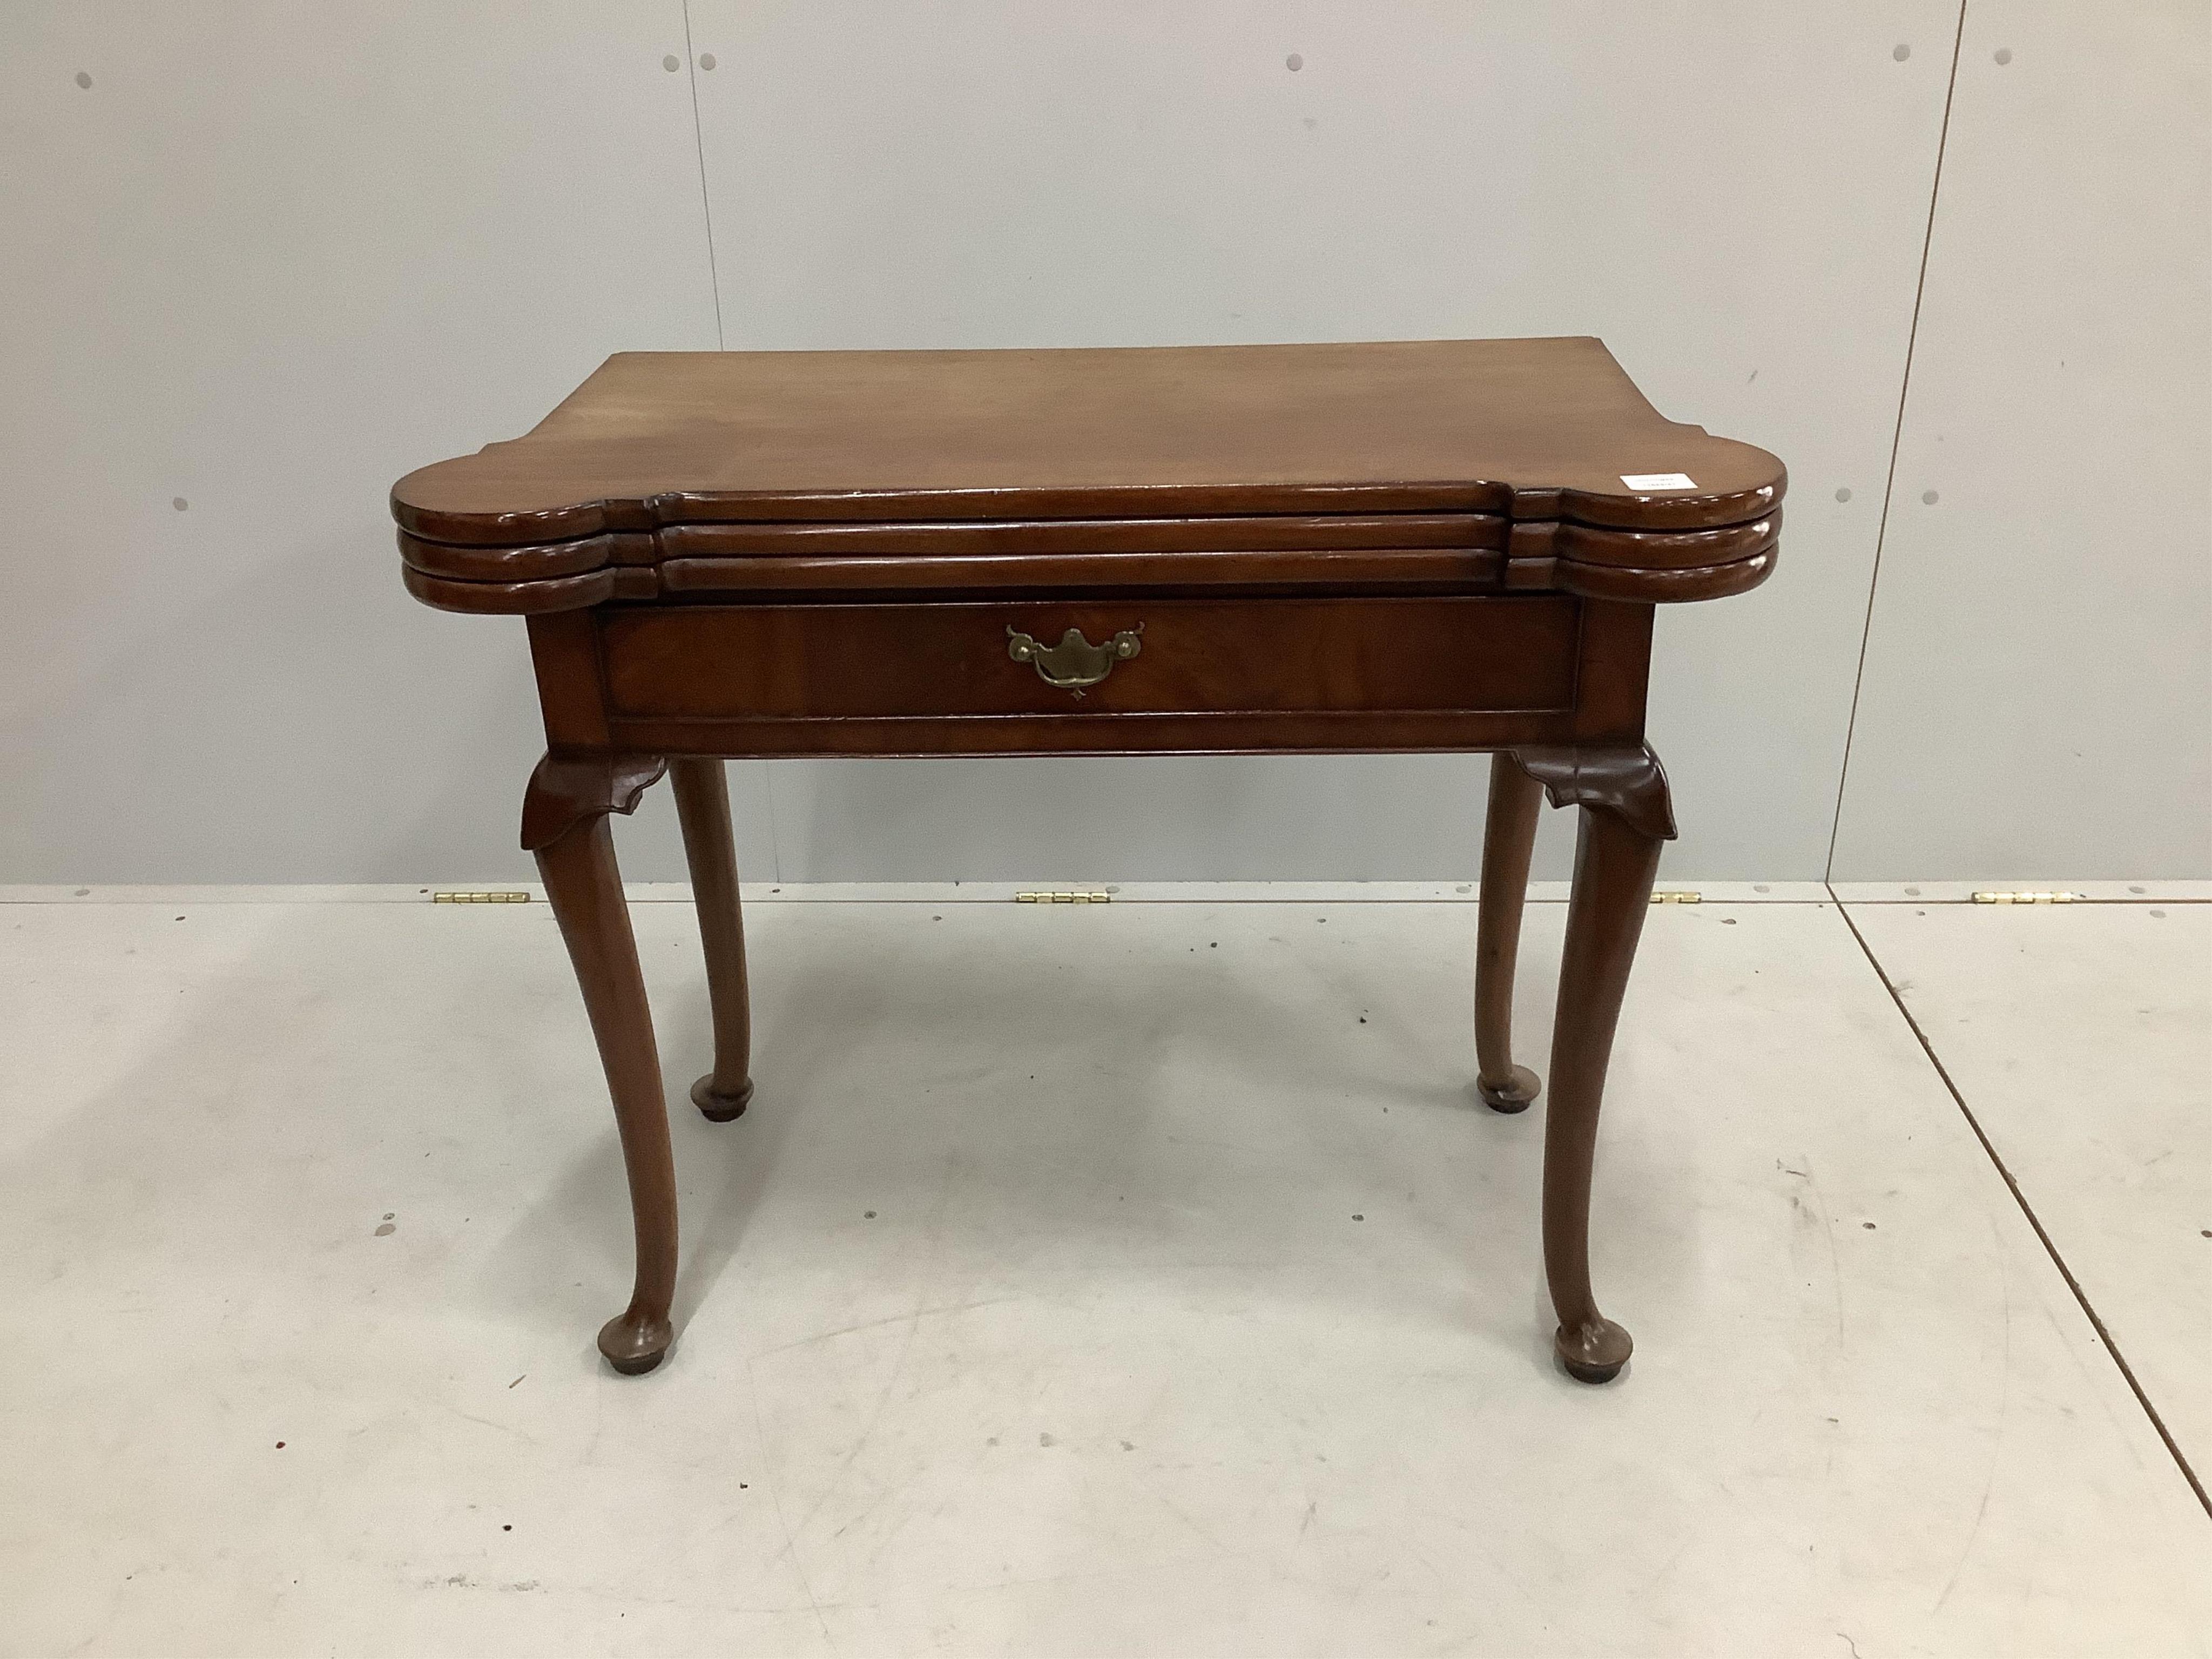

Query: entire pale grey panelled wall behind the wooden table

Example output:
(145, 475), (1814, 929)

(0, 0), (2212, 880)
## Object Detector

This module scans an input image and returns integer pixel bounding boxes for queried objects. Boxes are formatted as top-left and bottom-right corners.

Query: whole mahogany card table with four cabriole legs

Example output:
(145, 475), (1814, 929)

(392, 339), (1783, 1382)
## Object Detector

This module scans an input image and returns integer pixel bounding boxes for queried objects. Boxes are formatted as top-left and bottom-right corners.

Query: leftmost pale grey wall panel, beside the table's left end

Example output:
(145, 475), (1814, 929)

(0, 0), (767, 880)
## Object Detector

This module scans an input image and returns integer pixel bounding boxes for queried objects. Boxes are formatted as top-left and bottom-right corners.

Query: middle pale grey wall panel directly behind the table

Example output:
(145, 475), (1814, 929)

(692, 0), (1958, 878)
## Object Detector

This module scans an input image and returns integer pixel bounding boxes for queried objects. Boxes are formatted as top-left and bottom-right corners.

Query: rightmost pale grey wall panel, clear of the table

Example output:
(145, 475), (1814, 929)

(1834, 0), (2212, 880)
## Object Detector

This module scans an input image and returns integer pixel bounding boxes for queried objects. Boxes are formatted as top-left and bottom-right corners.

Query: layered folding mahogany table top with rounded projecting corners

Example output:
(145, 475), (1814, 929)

(392, 339), (1785, 610)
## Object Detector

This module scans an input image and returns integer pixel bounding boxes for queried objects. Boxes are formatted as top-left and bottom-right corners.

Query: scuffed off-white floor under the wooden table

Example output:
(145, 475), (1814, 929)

(0, 889), (2212, 1659)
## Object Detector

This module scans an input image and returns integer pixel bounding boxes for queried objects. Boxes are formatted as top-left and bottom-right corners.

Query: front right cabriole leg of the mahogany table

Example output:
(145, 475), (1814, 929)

(1520, 747), (1675, 1382)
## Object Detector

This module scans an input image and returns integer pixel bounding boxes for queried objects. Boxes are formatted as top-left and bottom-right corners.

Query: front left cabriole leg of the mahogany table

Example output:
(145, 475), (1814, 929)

(522, 757), (677, 1376)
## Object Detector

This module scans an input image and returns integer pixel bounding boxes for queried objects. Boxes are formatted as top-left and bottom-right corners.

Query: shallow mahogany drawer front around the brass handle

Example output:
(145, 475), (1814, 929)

(602, 595), (1580, 721)
